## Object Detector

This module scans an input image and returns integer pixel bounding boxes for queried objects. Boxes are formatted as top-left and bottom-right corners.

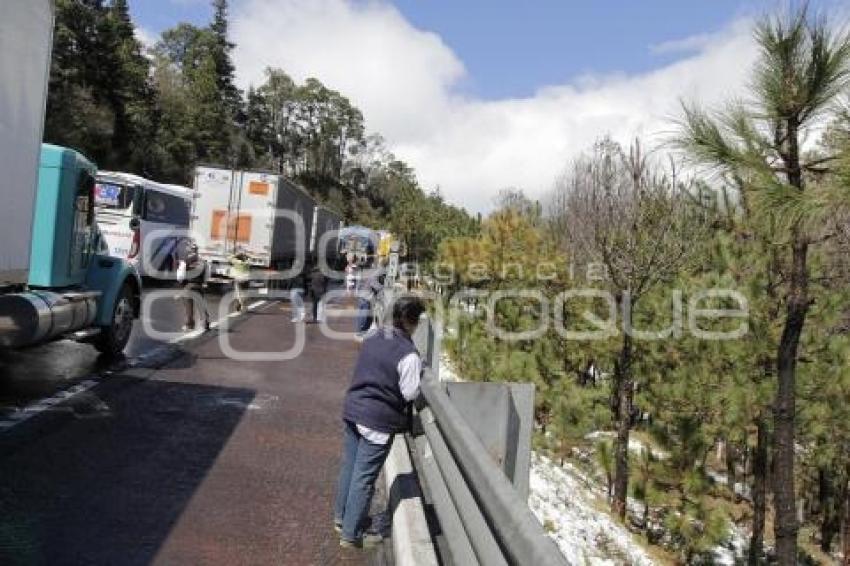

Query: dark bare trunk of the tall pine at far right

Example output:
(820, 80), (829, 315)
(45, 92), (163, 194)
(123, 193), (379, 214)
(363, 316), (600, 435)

(773, 237), (809, 566)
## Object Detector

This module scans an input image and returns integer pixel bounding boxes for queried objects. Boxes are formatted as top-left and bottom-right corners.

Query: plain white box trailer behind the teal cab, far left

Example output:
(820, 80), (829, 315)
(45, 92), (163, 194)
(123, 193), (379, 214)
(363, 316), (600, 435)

(0, 0), (54, 287)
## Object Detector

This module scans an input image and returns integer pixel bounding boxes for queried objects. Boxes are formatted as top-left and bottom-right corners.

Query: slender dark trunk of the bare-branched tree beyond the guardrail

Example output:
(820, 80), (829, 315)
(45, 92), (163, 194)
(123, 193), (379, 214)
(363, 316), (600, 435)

(611, 330), (634, 520)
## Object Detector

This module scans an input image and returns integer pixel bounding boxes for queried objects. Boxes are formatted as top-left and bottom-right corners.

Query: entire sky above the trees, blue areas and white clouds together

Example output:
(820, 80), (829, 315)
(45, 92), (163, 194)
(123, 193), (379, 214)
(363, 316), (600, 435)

(131, 0), (850, 212)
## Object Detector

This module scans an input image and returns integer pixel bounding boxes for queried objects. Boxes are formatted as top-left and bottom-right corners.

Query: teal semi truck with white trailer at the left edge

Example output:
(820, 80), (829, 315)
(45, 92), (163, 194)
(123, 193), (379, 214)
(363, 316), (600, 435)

(0, 0), (141, 355)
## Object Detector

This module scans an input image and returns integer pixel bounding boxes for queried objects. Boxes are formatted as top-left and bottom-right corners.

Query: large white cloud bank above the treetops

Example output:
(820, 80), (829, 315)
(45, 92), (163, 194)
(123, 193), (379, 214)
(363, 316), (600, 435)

(231, 0), (755, 210)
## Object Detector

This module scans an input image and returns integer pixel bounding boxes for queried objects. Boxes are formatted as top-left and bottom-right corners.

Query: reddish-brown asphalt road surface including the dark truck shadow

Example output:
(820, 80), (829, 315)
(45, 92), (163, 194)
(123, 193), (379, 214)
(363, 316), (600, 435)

(0, 288), (392, 566)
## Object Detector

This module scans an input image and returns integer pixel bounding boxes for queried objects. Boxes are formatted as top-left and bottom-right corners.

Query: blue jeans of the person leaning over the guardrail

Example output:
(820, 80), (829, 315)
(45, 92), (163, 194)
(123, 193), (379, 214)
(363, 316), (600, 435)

(334, 421), (392, 541)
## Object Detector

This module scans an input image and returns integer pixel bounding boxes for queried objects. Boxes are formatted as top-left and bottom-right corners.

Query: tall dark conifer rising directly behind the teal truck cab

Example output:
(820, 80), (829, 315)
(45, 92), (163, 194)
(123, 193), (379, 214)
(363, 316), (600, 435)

(45, 0), (157, 173)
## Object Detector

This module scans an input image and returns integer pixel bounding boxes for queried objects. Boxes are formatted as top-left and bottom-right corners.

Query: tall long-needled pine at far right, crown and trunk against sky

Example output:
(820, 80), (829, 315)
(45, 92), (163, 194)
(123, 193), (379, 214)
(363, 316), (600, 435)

(682, 7), (850, 566)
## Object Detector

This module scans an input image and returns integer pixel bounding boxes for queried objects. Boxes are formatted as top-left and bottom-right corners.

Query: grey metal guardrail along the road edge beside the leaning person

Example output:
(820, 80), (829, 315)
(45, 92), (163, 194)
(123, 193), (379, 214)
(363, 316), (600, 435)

(383, 290), (567, 566)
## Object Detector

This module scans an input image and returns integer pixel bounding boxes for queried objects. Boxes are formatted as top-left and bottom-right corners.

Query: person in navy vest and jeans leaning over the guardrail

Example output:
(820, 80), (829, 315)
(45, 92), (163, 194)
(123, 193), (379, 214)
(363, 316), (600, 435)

(334, 297), (425, 548)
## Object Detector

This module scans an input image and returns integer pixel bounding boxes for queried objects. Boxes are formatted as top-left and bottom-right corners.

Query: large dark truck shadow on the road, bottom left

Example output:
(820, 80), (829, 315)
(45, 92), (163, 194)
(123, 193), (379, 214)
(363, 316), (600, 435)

(0, 377), (255, 565)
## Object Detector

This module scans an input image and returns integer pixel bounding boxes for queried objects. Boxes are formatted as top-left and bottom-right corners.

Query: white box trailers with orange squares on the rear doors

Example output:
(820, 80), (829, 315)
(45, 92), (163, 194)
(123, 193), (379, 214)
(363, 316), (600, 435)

(192, 166), (342, 281)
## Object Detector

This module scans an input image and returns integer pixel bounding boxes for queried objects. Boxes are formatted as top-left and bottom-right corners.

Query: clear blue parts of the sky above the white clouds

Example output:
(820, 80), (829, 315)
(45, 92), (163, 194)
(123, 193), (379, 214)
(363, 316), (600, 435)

(131, 0), (837, 99)
